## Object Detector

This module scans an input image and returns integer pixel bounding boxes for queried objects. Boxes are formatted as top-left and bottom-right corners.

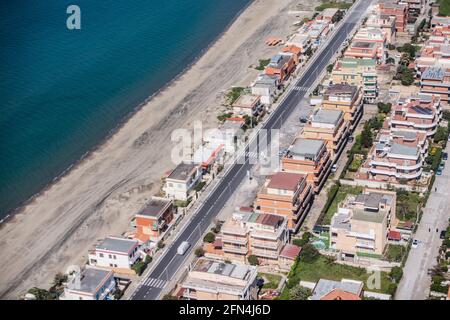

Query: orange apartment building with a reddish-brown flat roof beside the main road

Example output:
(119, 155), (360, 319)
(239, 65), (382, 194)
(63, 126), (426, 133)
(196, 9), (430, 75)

(255, 172), (313, 232)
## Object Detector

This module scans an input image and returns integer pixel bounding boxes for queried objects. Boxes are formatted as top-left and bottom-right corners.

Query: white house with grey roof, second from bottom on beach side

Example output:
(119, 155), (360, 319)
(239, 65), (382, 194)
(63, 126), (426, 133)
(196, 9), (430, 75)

(88, 237), (140, 272)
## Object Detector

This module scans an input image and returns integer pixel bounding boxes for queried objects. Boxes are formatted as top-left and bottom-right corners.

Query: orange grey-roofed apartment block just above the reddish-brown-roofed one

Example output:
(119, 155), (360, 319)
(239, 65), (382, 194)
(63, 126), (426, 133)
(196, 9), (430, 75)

(281, 138), (332, 193)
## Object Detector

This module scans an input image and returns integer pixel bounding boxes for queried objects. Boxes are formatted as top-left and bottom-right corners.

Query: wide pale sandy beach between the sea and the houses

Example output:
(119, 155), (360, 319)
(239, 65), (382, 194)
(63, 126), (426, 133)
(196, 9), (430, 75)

(0, 0), (317, 299)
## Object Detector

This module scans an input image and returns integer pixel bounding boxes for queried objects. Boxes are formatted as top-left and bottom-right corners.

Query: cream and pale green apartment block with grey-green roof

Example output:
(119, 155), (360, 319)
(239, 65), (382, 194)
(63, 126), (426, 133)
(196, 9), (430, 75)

(331, 58), (378, 103)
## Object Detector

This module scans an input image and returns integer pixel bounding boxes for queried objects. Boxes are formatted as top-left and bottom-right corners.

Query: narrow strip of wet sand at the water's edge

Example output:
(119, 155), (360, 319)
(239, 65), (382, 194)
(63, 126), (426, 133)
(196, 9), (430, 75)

(0, 0), (256, 226)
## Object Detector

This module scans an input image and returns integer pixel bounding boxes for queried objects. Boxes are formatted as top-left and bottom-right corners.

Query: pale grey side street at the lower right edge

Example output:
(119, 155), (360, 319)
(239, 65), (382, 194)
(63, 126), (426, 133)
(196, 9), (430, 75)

(395, 147), (450, 300)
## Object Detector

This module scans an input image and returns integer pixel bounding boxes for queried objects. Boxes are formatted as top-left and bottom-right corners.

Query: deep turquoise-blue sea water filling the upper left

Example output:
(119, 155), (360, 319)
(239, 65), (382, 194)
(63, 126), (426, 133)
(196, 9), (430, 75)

(0, 0), (251, 218)
